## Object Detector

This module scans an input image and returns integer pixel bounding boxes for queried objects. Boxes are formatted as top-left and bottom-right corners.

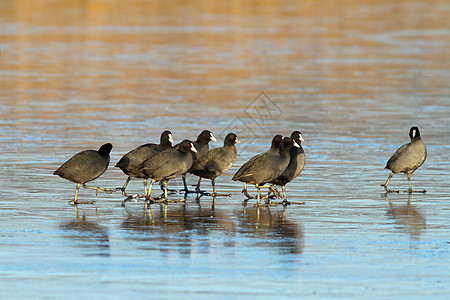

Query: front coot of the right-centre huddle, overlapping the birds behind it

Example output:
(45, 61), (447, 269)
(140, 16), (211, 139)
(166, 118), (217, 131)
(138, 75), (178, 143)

(233, 137), (299, 205)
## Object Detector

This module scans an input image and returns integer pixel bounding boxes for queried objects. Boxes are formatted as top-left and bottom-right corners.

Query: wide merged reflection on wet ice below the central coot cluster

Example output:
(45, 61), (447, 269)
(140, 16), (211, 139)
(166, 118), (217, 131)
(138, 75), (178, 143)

(121, 202), (304, 257)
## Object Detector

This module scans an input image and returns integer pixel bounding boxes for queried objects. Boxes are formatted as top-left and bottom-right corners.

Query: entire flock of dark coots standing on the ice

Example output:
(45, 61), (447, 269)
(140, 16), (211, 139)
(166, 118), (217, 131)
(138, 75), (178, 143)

(53, 126), (427, 207)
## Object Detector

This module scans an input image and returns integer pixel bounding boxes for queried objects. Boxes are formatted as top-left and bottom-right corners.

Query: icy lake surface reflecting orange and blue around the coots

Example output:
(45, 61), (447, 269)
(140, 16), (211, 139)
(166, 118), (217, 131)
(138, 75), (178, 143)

(0, 0), (450, 299)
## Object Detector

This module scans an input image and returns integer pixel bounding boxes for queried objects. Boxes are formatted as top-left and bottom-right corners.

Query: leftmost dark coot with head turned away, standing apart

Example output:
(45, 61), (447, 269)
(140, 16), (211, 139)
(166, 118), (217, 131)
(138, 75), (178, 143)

(53, 143), (112, 204)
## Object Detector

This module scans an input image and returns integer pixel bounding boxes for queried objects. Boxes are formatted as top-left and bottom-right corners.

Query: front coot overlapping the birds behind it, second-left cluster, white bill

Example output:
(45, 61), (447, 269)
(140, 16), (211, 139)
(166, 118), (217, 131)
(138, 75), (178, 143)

(138, 140), (197, 204)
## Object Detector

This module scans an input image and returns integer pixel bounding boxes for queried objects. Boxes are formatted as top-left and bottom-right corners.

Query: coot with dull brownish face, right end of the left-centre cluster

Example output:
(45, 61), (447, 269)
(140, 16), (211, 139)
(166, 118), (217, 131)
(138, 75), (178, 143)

(189, 132), (240, 196)
